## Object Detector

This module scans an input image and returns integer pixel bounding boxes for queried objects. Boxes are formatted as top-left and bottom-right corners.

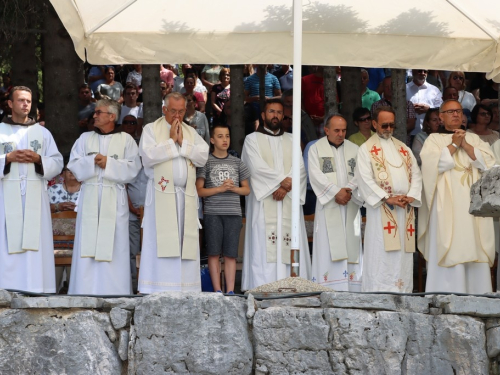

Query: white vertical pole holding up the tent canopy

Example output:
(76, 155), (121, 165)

(290, 0), (302, 277)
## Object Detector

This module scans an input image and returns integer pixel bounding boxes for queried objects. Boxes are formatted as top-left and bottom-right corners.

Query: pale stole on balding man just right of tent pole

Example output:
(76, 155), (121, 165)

(316, 137), (361, 263)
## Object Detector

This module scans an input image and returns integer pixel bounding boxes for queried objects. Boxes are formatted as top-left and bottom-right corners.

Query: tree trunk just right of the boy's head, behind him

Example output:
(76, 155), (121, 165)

(230, 65), (245, 155)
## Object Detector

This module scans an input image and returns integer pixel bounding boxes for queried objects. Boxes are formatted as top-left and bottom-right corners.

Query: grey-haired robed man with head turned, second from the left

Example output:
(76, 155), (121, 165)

(68, 99), (141, 295)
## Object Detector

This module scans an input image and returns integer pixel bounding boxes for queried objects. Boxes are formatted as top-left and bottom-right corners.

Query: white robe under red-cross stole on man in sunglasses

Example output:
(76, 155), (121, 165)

(355, 139), (422, 293)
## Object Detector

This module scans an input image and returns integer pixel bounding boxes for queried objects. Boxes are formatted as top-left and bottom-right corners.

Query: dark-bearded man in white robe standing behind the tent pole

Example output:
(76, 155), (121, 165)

(241, 99), (311, 290)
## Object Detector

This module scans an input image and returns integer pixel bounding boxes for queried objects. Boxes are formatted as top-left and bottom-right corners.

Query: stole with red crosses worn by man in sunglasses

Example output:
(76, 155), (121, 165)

(364, 134), (416, 253)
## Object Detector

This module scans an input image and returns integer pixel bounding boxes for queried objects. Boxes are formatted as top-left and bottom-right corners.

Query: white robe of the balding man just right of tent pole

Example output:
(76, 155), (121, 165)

(308, 141), (363, 292)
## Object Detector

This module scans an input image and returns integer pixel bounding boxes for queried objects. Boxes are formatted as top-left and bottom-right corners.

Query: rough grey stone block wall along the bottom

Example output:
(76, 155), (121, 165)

(0, 290), (500, 375)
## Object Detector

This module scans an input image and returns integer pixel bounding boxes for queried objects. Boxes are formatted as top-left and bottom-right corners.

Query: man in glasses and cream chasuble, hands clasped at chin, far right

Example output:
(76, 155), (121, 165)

(418, 100), (495, 293)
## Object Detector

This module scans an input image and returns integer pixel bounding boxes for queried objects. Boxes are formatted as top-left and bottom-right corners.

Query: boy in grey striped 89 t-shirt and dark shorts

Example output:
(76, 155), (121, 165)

(196, 125), (250, 294)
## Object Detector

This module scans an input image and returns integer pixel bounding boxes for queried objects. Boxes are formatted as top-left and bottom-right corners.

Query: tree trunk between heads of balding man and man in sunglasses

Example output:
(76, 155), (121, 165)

(341, 67), (361, 138)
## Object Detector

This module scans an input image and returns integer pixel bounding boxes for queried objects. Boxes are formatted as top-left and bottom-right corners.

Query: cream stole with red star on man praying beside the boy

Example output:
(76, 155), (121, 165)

(153, 117), (199, 260)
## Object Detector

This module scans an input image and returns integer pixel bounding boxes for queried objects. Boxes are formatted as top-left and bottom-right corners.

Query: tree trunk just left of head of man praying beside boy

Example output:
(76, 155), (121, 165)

(142, 64), (161, 125)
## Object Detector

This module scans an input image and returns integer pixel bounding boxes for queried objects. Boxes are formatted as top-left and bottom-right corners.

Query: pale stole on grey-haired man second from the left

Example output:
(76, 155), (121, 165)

(81, 132), (127, 262)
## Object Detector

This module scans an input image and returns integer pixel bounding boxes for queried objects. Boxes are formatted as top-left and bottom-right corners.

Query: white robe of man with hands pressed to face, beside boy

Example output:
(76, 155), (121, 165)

(138, 123), (209, 293)
